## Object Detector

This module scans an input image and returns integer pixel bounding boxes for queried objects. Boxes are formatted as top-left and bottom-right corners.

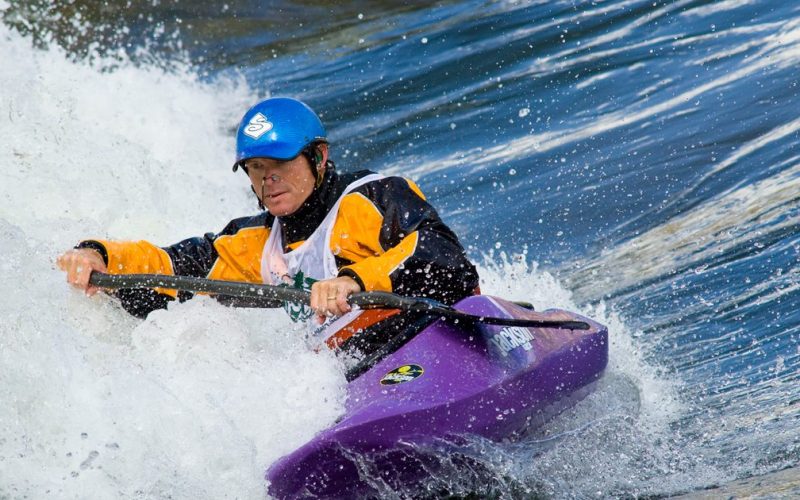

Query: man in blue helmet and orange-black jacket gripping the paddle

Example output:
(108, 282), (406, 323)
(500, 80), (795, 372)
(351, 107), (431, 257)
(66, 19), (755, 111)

(57, 98), (478, 328)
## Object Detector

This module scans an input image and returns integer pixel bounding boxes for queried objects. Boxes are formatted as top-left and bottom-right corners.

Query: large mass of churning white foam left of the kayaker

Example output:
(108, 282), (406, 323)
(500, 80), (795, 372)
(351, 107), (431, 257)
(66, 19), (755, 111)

(0, 21), (344, 498)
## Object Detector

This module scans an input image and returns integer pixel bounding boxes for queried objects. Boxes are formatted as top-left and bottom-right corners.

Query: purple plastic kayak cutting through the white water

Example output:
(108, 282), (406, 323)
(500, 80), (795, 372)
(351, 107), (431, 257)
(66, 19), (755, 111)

(266, 295), (608, 498)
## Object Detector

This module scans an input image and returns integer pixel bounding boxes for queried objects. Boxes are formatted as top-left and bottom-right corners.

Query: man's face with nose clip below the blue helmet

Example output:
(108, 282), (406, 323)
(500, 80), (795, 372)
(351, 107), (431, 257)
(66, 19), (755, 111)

(245, 155), (315, 217)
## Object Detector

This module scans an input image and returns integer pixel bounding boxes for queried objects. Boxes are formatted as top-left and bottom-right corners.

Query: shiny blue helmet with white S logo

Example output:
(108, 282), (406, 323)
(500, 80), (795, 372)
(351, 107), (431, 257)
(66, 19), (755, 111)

(233, 97), (327, 171)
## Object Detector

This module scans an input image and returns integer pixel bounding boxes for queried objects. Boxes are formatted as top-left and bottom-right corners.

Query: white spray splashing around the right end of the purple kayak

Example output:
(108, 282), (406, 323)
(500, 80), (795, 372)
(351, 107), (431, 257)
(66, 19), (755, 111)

(481, 253), (704, 498)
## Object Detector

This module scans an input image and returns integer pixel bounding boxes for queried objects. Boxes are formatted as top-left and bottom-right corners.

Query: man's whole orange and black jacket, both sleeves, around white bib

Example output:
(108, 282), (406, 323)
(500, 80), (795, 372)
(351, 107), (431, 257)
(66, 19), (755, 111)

(78, 162), (478, 317)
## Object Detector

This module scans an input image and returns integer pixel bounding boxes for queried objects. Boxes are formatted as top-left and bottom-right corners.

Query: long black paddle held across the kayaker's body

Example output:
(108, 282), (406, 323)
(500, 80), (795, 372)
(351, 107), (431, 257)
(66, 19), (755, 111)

(89, 271), (590, 330)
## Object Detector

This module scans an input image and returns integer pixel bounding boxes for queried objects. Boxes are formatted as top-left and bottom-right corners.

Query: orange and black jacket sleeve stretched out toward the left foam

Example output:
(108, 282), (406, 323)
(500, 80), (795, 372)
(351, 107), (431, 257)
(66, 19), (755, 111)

(76, 215), (269, 318)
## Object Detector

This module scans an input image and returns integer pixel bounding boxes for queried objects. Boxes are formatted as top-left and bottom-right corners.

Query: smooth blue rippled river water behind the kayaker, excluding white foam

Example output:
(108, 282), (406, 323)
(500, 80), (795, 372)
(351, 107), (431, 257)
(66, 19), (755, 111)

(0, 0), (800, 498)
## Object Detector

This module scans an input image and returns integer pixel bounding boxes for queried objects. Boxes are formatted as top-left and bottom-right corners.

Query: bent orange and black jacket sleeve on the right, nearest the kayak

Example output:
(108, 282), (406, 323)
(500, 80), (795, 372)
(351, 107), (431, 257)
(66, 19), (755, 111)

(331, 177), (478, 304)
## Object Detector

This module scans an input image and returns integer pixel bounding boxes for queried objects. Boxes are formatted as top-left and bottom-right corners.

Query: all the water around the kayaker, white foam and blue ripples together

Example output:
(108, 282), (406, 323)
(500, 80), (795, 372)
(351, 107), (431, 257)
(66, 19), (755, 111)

(0, 0), (800, 498)
